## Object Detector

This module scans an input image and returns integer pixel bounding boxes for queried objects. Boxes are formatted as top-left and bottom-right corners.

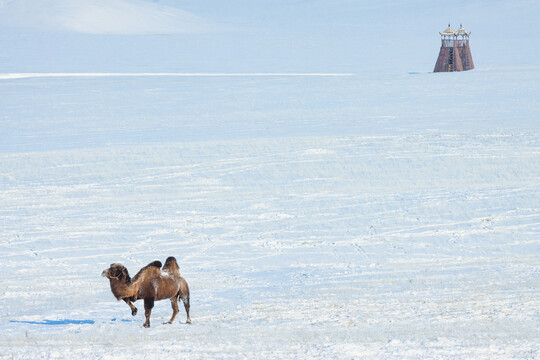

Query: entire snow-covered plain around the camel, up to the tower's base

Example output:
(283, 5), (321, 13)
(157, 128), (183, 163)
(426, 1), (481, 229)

(0, 67), (540, 359)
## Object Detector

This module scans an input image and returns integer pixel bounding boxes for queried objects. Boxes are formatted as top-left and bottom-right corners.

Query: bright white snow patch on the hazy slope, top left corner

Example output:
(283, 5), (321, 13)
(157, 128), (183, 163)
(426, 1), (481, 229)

(0, 0), (212, 35)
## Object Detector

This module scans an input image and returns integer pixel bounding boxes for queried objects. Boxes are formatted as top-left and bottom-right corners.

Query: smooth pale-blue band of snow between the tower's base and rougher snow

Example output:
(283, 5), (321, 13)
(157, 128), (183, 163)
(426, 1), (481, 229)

(0, 68), (540, 152)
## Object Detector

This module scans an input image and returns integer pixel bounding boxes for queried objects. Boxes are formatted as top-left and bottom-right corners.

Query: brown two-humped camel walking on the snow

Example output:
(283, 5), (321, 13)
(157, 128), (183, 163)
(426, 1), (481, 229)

(101, 256), (191, 328)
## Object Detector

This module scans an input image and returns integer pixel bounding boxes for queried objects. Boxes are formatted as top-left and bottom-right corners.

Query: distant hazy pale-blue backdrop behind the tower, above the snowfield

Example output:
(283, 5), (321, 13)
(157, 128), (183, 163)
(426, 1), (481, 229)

(0, 0), (540, 73)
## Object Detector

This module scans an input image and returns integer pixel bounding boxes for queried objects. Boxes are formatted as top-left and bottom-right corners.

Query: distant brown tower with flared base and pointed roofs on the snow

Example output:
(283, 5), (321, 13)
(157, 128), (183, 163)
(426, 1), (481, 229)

(433, 24), (474, 72)
